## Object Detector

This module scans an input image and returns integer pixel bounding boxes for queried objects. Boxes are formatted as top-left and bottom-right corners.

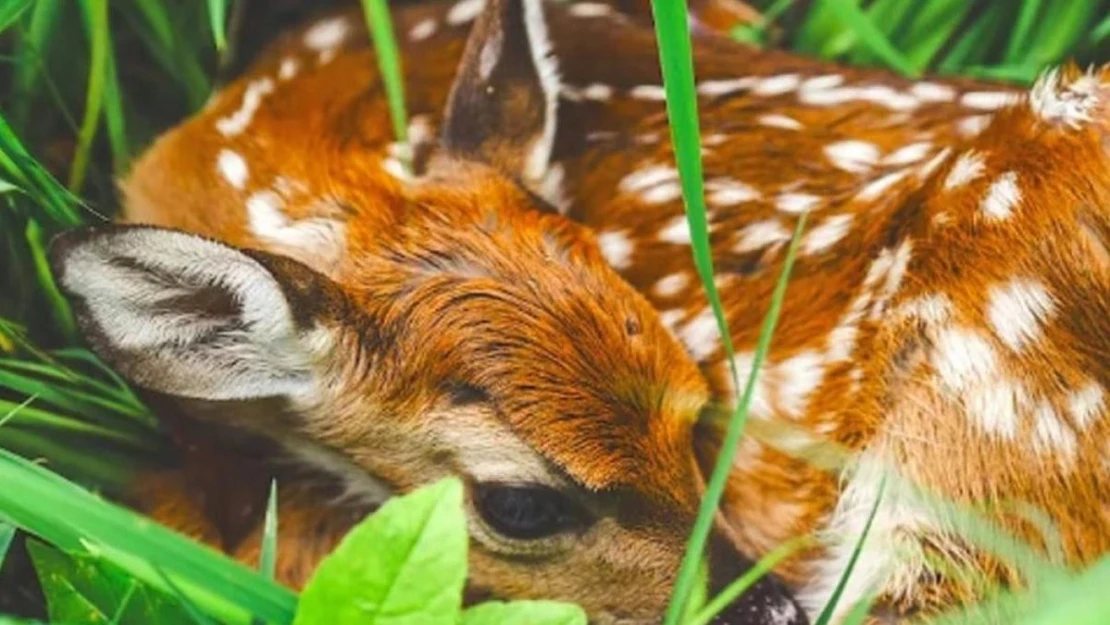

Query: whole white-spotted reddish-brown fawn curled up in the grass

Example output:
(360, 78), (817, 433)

(47, 0), (1110, 623)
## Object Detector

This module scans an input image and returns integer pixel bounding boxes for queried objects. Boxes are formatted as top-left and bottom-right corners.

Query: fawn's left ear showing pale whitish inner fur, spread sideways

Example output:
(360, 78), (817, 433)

(50, 225), (341, 400)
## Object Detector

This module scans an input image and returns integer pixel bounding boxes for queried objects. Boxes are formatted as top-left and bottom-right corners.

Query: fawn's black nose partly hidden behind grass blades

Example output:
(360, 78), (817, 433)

(709, 537), (809, 625)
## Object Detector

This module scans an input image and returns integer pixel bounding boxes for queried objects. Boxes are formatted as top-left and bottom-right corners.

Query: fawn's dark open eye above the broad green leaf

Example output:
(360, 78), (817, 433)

(474, 484), (586, 541)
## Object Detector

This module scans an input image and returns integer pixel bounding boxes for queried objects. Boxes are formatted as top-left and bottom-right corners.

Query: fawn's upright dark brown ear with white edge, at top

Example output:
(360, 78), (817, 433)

(443, 0), (559, 185)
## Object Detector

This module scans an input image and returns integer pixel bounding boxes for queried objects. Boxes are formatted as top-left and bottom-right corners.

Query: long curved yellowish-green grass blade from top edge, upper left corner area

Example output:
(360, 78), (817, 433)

(67, 0), (109, 193)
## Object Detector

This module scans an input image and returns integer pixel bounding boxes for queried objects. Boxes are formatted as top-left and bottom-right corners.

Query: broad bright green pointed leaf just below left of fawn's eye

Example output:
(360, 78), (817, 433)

(293, 478), (467, 625)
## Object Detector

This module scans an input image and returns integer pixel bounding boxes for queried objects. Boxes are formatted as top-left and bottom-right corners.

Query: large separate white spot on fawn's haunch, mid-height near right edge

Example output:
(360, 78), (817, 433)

(987, 279), (1056, 352)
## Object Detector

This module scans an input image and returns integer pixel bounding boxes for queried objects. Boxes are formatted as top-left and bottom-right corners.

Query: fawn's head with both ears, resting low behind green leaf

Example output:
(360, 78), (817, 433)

(52, 0), (804, 624)
